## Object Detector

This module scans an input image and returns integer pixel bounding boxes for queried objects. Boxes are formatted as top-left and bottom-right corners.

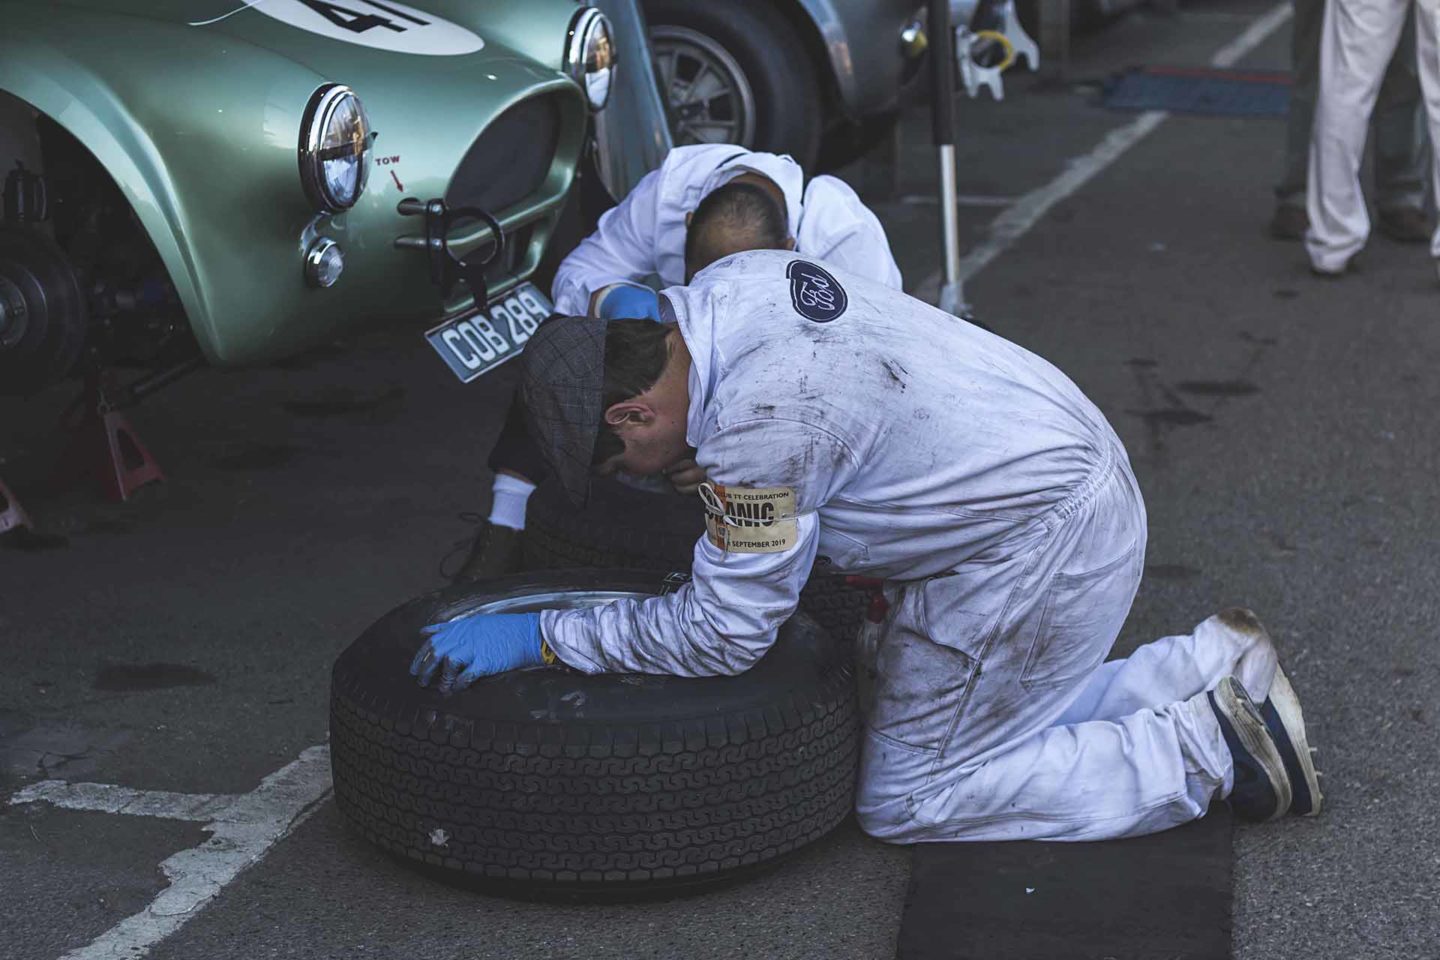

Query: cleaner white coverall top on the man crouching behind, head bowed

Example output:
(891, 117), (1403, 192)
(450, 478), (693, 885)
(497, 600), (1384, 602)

(550, 144), (900, 317)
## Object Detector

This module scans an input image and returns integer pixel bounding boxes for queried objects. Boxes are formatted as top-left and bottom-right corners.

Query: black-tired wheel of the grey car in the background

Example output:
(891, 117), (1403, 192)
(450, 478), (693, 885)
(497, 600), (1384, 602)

(645, 0), (825, 170)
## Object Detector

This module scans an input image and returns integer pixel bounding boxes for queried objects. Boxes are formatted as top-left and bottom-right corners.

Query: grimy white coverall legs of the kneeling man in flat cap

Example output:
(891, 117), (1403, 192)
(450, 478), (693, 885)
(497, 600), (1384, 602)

(857, 452), (1276, 843)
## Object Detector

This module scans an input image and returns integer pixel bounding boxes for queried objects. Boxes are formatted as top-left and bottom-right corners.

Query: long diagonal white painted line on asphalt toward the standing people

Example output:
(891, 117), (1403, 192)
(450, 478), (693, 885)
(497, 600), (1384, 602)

(914, 0), (1292, 294)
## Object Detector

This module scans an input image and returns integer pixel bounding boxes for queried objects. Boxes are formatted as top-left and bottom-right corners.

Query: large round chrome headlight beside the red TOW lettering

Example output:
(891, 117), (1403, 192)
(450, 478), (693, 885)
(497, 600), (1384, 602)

(300, 83), (373, 213)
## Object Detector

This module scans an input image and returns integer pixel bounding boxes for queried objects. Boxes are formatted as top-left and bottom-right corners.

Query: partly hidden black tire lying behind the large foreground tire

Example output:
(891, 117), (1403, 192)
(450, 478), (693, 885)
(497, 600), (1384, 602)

(521, 479), (871, 640)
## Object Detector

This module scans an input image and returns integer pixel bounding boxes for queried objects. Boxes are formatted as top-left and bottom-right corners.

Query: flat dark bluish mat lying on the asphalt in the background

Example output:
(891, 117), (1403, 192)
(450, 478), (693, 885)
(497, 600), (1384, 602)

(1100, 66), (1290, 117)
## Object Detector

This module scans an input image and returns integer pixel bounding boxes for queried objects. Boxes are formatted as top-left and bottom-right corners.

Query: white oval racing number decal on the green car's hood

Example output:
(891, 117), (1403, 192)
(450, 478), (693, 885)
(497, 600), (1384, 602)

(239, 0), (485, 56)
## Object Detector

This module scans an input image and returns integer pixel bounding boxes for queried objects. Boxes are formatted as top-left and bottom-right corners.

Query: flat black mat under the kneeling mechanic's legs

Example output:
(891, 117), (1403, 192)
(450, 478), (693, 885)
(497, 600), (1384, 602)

(897, 805), (1233, 960)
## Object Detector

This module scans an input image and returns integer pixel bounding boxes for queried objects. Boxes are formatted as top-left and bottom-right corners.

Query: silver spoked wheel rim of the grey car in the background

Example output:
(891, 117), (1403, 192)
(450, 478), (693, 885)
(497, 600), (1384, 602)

(649, 26), (755, 147)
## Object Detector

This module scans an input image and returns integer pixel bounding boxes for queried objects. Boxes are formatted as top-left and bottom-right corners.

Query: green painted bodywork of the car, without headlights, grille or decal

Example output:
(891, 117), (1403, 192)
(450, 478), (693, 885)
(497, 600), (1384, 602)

(0, 0), (588, 366)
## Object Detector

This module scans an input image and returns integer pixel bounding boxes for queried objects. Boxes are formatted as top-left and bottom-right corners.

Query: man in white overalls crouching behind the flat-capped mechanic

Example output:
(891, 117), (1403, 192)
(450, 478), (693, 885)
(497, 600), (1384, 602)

(459, 144), (900, 579)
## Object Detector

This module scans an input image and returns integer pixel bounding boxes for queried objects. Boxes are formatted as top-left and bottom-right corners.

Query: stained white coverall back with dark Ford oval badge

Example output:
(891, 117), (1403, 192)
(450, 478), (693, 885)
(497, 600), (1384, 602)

(667, 252), (1123, 577)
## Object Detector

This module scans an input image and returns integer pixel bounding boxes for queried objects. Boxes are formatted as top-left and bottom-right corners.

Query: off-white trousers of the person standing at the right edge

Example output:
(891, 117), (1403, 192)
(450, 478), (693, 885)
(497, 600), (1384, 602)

(1305, 0), (1440, 273)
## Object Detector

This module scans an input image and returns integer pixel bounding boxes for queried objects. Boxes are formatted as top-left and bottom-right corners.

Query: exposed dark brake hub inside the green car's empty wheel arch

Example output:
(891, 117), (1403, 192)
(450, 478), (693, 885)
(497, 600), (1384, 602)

(0, 226), (86, 396)
